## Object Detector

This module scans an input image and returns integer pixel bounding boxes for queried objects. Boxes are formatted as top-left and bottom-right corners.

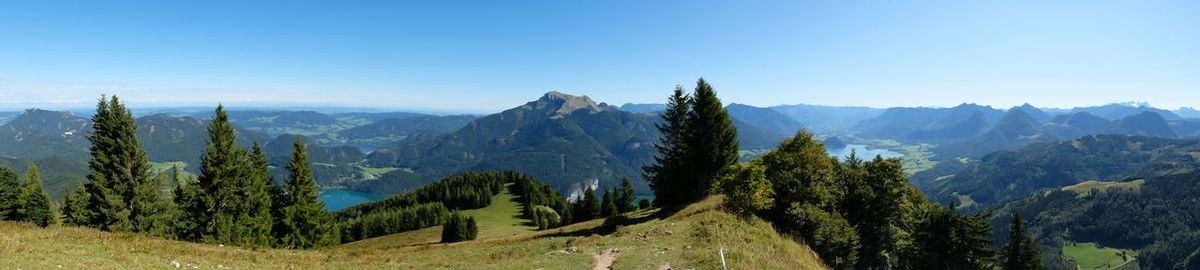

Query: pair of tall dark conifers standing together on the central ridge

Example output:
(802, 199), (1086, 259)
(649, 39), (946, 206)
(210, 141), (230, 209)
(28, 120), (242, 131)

(643, 79), (738, 206)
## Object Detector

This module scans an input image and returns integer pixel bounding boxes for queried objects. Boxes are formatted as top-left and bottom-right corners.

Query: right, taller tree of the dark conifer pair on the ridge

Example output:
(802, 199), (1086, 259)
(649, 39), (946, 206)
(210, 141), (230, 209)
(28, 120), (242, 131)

(679, 78), (738, 203)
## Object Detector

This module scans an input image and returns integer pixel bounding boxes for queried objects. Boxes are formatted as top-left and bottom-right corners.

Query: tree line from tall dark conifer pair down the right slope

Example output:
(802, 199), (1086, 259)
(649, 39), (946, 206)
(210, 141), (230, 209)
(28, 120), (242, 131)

(643, 79), (1042, 269)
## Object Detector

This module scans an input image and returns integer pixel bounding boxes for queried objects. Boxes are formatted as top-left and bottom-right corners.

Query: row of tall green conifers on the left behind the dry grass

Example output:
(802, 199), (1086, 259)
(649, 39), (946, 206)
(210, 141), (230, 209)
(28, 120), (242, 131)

(27, 96), (338, 248)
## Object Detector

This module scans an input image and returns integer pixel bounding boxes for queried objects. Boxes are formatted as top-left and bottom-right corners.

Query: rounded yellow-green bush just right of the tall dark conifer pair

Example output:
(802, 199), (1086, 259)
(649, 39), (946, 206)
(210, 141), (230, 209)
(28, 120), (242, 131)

(713, 160), (775, 215)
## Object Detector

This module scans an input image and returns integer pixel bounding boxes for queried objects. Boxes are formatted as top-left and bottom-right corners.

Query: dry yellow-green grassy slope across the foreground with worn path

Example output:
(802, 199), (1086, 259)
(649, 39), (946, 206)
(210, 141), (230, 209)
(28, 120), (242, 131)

(0, 198), (823, 269)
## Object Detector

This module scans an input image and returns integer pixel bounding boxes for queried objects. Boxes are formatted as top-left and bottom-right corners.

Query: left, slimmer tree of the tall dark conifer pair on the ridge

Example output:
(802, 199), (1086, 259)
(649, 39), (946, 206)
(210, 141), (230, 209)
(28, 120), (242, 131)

(643, 86), (691, 205)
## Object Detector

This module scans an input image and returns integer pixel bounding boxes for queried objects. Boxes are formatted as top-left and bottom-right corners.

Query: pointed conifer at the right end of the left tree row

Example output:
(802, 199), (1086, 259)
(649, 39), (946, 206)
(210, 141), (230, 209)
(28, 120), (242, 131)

(282, 139), (338, 248)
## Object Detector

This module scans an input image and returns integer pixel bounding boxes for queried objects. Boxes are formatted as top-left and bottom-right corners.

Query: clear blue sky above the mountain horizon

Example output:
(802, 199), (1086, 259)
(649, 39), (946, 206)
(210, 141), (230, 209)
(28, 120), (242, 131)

(0, 0), (1200, 112)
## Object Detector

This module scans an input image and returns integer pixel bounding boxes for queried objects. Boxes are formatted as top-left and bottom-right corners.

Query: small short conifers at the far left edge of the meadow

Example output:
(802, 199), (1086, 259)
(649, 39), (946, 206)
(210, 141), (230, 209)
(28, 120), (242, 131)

(0, 164), (56, 227)
